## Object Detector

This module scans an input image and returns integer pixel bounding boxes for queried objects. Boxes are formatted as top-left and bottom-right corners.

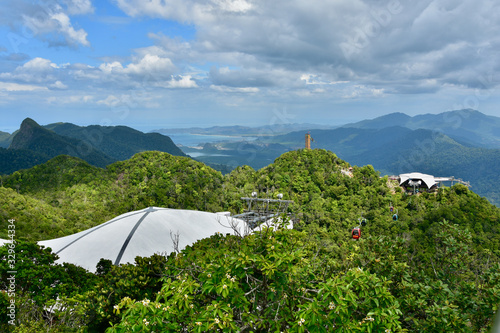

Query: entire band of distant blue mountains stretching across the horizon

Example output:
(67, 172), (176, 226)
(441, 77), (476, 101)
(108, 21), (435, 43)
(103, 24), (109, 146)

(0, 109), (500, 205)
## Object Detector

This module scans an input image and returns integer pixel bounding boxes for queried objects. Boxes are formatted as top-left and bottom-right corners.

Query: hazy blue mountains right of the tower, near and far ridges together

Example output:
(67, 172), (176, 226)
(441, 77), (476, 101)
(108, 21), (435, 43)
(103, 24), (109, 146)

(261, 110), (500, 205)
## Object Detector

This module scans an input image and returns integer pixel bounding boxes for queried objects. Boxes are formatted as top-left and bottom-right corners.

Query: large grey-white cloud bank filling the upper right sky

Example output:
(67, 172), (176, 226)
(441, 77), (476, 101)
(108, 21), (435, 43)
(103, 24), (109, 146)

(117, 0), (500, 93)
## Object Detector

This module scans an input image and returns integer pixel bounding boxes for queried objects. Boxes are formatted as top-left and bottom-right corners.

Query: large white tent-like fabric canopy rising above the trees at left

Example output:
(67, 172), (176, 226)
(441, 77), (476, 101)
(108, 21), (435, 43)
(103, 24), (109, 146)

(38, 207), (245, 272)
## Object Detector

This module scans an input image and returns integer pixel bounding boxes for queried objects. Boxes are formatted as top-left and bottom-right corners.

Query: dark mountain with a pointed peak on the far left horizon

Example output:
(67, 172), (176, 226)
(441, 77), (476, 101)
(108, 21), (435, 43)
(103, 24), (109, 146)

(0, 118), (186, 174)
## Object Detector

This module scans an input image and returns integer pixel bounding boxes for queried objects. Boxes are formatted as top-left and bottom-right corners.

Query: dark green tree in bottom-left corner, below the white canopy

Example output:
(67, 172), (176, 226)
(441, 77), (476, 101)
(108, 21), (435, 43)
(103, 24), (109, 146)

(0, 241), (96, 332)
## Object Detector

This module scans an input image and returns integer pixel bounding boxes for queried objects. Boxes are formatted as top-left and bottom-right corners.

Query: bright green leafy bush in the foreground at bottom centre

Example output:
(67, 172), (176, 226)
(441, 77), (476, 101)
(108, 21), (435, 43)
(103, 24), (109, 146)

(108, 229), (401, 332)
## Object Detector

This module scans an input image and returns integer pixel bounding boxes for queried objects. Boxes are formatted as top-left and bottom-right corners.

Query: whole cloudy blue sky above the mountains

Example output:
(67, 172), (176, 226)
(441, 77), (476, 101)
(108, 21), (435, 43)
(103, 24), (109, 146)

(0, 0), (500, 133)
